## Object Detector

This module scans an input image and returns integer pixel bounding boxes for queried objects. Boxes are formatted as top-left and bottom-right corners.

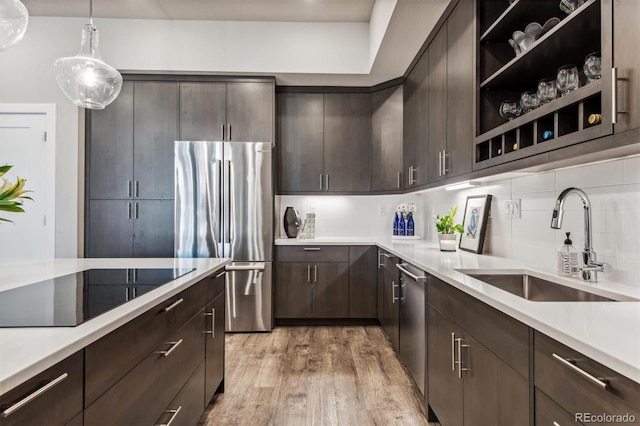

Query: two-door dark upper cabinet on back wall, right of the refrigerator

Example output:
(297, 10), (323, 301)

(278, 92), (371, 194)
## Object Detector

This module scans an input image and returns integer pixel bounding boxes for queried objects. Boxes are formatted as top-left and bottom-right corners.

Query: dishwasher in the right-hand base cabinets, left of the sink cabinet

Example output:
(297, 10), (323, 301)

(396, 263), (427, 395)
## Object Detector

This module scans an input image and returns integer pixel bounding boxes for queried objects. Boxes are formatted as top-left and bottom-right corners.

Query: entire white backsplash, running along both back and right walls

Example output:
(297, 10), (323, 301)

(276, 156), (640, 287)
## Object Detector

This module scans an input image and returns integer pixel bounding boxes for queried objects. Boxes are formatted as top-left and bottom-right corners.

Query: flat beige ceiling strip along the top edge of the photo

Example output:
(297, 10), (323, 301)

(23, 0), (375, 22)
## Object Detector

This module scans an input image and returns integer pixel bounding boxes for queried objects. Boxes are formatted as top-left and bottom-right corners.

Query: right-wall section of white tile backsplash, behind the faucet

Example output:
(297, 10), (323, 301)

(416, 156), (640, 287)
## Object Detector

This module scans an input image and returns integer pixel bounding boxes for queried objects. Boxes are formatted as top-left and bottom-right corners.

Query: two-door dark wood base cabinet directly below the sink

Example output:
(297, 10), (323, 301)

(427, 306), (529, 426)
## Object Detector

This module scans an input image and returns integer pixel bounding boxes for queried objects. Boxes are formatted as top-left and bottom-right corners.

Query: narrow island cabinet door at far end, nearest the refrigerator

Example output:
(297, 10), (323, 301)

(204, 292), (225, 405)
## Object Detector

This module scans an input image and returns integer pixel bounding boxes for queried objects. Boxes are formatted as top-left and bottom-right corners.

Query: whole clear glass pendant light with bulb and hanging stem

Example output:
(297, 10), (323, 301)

(53, 0), (122, 109)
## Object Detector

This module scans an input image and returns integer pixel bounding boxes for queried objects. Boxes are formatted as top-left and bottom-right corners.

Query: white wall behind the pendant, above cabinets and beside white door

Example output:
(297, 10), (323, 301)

(0, 17), (369, 257)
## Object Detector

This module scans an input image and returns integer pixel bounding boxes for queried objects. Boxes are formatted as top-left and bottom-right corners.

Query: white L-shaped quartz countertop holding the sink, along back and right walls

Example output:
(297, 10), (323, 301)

(276, 237), (640, 383)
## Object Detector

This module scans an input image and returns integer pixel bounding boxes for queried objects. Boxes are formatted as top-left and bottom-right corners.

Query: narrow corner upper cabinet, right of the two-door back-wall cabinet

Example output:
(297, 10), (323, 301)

(371, 85), (403, 192)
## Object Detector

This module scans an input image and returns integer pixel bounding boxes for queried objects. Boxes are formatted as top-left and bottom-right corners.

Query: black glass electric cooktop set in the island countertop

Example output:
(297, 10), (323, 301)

(0, 268), (194, 327)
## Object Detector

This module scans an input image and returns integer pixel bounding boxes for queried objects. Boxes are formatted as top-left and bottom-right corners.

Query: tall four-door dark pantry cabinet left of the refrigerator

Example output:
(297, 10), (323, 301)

(85, 81), (178, 257)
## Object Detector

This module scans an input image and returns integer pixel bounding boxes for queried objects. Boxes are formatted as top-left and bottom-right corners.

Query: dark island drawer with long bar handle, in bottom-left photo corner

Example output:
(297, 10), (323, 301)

(0, 351), (84, 426)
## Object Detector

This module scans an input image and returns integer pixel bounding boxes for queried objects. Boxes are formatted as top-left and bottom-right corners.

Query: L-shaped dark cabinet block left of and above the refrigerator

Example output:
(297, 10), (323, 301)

(85, 76), (275, 257)
